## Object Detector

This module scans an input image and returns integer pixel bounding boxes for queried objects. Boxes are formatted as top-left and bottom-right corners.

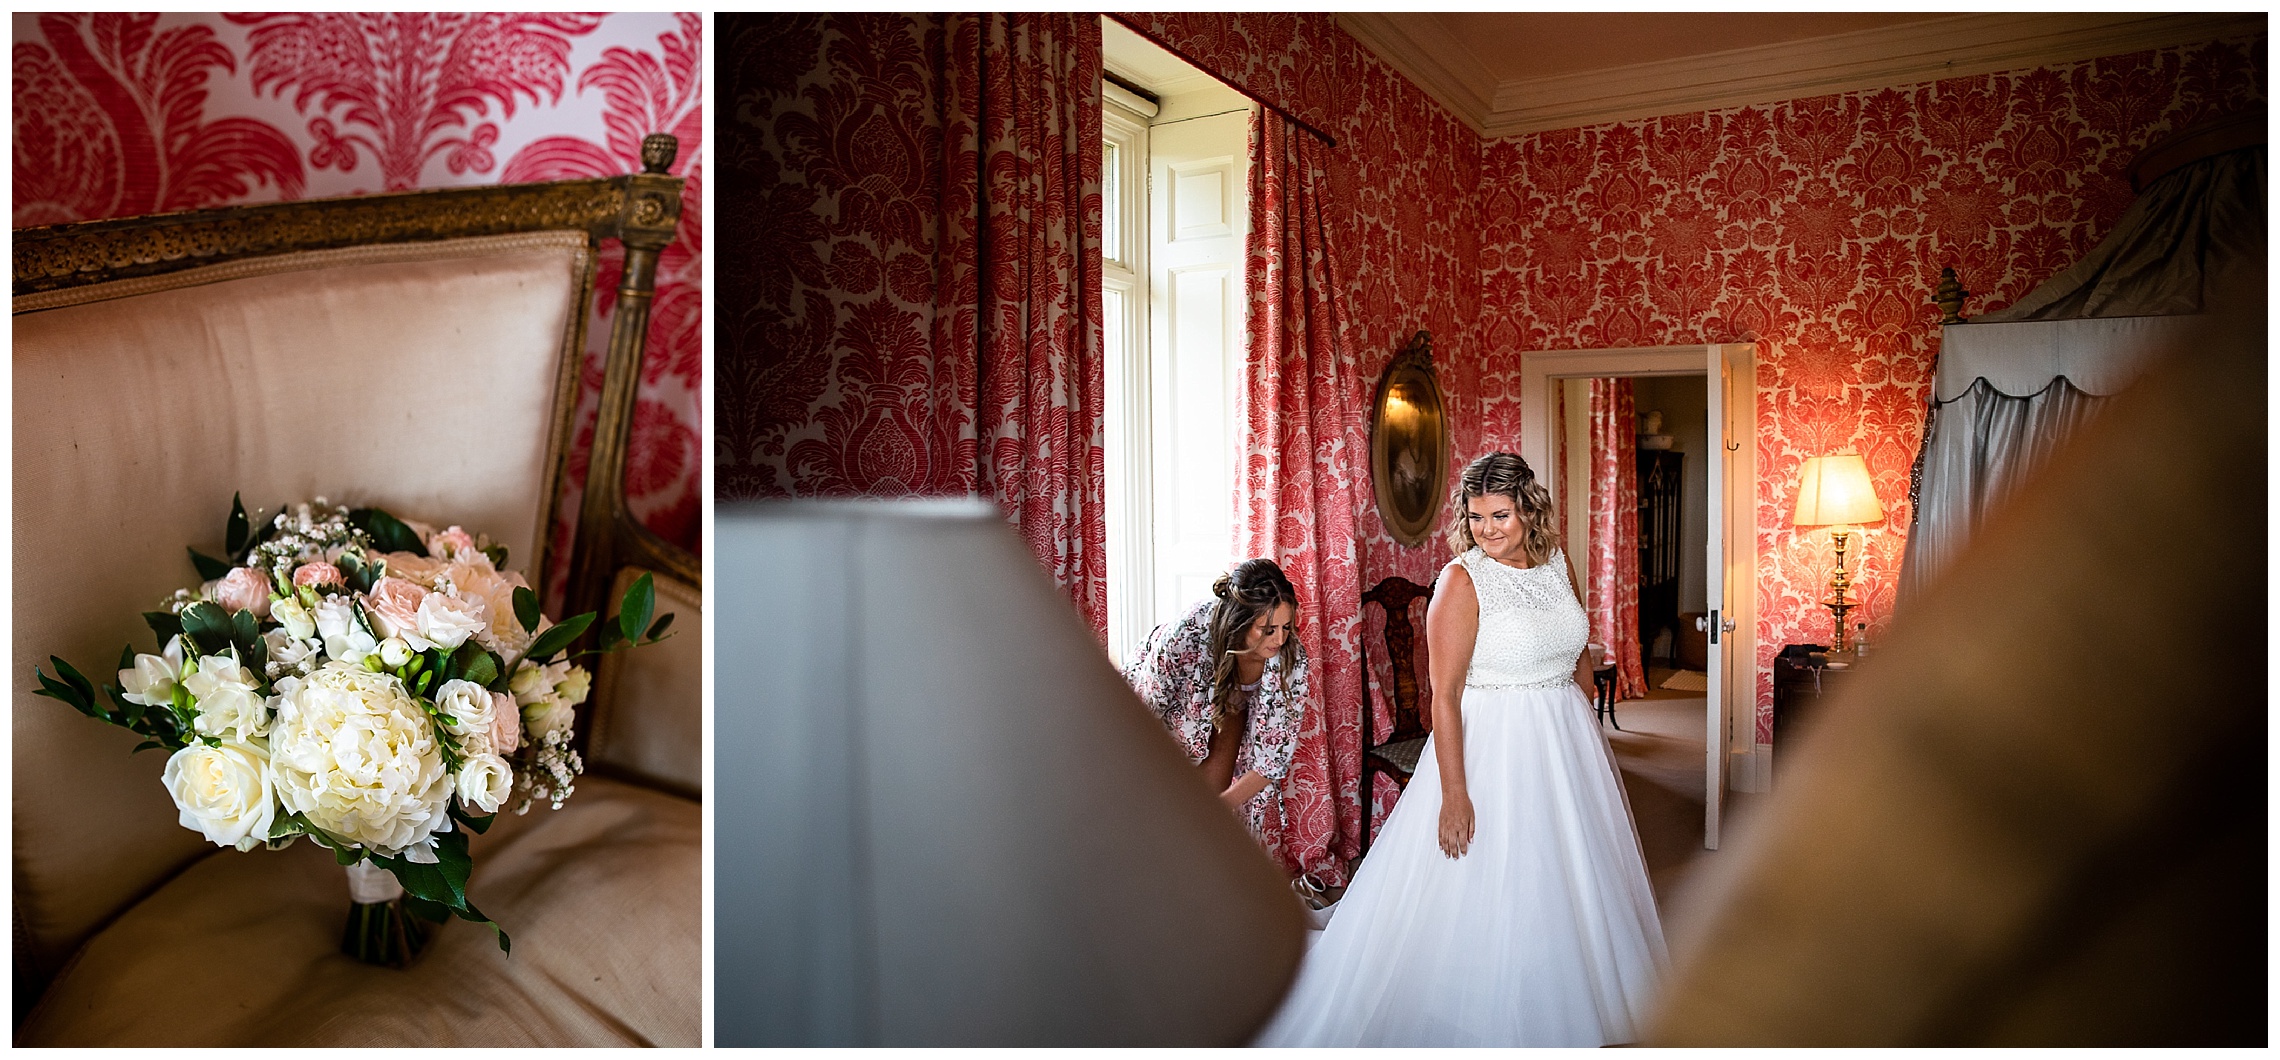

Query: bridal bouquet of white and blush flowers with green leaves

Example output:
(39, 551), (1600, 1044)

(34, 497), (673, 964)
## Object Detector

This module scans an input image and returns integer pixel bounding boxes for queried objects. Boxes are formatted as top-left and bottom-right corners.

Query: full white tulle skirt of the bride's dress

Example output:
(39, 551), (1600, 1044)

(1256, 684), (1669, 1046)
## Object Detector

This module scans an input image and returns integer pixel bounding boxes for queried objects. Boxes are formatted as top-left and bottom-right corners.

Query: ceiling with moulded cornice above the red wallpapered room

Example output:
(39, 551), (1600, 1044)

(1336, 11), (2266, 137)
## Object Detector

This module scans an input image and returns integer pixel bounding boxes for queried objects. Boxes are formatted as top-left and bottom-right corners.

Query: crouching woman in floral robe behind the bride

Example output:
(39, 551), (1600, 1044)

(1124, 558), (1306, 841)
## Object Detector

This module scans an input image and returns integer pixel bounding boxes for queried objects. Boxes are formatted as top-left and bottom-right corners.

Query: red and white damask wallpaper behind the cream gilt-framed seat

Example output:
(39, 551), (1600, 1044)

(14, 11), (705, 579)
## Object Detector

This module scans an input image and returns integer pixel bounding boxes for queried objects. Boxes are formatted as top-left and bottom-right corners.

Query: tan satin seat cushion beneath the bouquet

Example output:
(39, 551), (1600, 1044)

(16, 777), (702, 1046)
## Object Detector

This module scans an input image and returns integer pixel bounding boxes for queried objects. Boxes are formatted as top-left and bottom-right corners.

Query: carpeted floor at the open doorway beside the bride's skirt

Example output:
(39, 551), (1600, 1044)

(1601, 666), (1758, 935)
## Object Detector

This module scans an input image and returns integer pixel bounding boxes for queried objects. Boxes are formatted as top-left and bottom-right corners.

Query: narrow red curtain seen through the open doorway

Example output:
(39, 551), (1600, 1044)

(1587, 378), (1646, 700)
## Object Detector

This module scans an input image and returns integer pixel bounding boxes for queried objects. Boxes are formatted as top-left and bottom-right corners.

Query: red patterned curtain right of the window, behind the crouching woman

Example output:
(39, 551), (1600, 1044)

(1236, 114), (1370, 884)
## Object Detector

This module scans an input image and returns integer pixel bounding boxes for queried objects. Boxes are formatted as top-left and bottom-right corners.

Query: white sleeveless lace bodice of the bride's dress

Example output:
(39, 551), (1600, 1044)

(1457, 547), (1587, 688)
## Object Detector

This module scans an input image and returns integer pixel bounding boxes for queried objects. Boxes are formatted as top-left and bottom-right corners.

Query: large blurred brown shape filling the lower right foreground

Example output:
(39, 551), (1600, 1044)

(1653, 296), (2269, 1046)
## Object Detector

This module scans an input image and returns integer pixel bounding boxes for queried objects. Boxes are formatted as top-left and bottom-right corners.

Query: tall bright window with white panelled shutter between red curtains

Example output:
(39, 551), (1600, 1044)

(1101, 82), (1249, 663)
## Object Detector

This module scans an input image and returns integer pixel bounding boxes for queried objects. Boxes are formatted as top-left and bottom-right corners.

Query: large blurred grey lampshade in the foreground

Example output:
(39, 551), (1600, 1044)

(714, 502), (1304, 1046)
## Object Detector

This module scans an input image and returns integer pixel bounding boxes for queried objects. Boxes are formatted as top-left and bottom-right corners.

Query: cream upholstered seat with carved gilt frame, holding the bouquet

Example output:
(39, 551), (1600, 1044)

(11, 137), (702, 1046)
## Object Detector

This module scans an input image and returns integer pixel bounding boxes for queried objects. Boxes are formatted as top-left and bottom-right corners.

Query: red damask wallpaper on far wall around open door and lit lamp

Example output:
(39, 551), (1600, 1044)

(1480, 39), (2266, 741)
